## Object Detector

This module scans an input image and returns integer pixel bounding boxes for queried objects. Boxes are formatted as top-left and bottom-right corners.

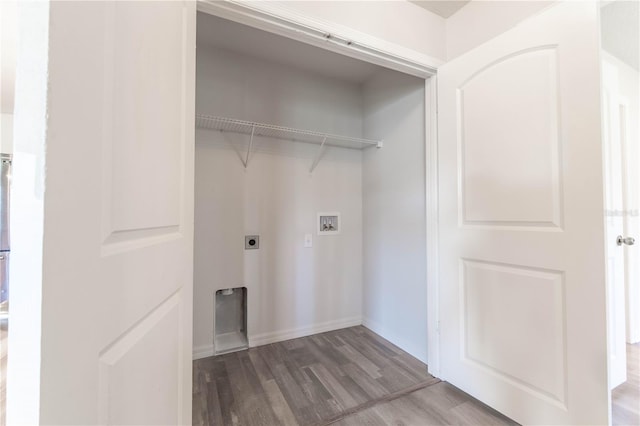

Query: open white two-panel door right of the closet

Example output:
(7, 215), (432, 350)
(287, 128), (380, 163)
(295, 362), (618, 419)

(438, 2), (609, 424)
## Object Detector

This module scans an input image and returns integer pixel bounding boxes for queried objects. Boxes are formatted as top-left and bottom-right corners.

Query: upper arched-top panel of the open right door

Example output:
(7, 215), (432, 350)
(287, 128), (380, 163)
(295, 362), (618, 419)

(458, 46), (561, 228)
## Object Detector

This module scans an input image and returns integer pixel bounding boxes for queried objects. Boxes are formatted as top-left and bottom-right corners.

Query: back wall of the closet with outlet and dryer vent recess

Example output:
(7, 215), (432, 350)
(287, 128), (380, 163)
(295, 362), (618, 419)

(194, 46), (362, 357)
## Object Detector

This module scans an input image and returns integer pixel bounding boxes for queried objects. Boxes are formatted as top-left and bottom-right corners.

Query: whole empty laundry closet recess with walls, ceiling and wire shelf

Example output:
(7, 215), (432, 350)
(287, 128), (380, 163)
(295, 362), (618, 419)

(194, 12), (427, 362)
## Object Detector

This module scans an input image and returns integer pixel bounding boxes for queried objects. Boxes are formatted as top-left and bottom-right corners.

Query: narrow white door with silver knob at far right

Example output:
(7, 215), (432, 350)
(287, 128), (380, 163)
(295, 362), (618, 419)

(602, 62), (628, 389)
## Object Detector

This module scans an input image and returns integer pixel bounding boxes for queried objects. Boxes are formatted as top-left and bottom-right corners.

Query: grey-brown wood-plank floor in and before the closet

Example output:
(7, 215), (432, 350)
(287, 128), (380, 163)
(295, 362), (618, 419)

(193, 326), (515, 426)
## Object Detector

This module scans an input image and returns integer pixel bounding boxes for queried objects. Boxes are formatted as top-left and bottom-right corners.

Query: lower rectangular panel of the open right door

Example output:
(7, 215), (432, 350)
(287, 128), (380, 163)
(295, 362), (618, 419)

(461, 260), (566, 403)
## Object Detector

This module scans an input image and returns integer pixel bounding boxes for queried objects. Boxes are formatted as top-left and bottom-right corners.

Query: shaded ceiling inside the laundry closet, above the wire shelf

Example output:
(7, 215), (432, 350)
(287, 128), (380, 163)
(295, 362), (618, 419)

(197, 13), (380, 84)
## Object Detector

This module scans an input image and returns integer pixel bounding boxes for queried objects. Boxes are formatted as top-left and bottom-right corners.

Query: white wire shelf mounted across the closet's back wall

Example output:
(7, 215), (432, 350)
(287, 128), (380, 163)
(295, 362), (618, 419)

(196, 114), (382, 149)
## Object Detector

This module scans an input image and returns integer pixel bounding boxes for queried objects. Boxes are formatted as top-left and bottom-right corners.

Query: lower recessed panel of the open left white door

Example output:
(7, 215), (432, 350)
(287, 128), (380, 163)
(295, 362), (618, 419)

(99, 294), (182, 425)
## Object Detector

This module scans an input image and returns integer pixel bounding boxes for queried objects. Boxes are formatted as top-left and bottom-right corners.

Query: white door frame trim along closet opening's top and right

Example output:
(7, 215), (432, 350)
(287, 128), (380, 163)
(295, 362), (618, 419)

(197, 0), (444, 377)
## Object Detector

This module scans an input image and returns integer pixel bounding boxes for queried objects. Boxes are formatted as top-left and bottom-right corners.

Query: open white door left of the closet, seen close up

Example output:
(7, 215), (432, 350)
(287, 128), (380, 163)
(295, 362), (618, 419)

(9, 1), (196, 425)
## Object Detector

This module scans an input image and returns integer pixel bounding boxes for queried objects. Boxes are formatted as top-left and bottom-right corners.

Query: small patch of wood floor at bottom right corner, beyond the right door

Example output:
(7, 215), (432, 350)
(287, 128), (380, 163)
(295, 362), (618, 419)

(611, 343), (640, 426)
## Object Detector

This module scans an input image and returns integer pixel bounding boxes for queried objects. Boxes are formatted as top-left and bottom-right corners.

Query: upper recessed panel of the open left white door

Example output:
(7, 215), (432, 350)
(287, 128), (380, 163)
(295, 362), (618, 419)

(105, 2), (185, 238)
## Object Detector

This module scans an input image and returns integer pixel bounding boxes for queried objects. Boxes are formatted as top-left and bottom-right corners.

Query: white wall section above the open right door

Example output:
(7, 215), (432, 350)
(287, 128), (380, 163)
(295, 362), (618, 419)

(446, 0), (554, 60)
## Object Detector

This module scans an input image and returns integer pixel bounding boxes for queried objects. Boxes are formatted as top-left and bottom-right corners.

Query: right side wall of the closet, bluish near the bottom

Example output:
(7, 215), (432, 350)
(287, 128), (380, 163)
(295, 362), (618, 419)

(363, 72), (427, 363)
